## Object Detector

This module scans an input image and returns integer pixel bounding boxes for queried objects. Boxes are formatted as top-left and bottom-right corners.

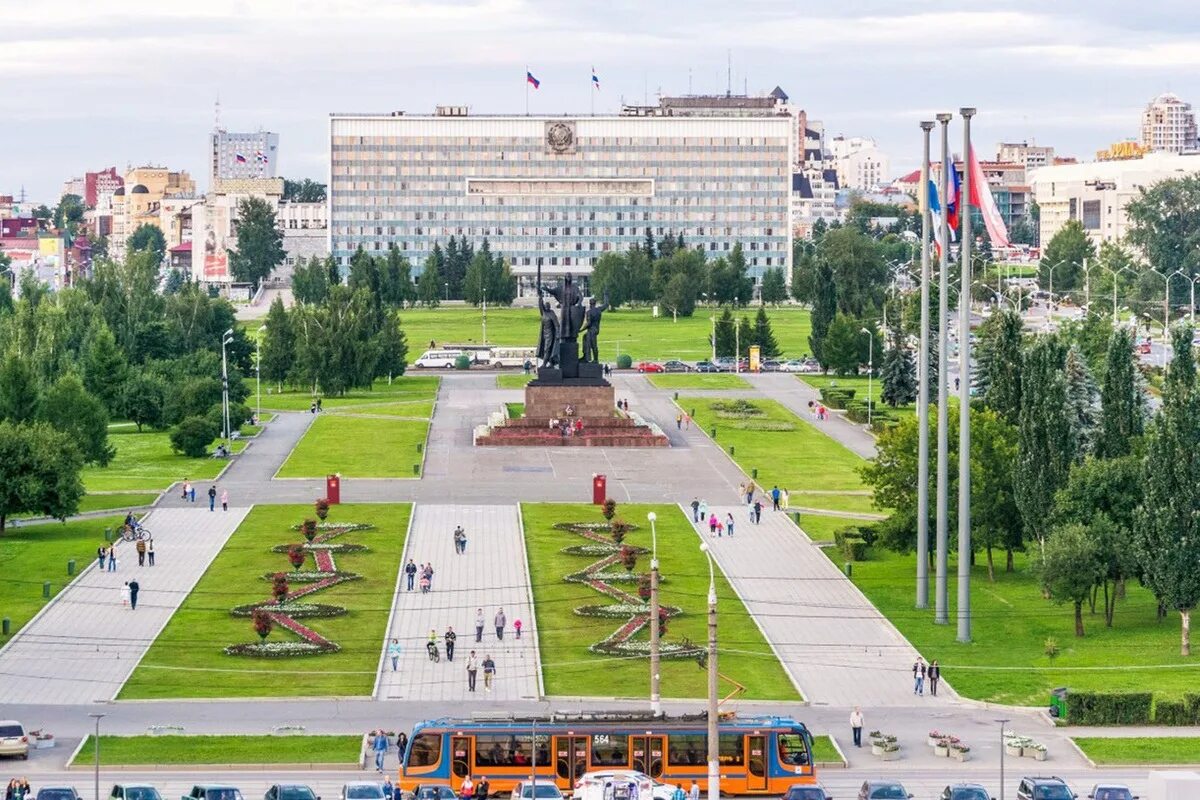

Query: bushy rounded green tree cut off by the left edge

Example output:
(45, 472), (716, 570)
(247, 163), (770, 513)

(0, 421), (84, 535)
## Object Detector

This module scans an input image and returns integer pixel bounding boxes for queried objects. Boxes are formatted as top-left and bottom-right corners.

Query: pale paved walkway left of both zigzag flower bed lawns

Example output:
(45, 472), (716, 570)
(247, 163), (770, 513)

(0, 510), (250, 705)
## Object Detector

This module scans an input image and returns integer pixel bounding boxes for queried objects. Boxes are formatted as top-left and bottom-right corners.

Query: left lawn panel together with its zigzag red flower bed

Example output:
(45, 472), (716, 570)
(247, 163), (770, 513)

(120, 504), (412, 699)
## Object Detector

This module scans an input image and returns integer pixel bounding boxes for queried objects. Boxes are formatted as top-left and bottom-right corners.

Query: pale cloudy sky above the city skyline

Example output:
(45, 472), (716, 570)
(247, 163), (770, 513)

(0, 0), (1200, 204)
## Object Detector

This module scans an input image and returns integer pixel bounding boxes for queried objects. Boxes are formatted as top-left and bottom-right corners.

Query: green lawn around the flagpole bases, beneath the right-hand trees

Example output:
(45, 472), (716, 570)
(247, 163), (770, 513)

(840, 546), (1200, 705)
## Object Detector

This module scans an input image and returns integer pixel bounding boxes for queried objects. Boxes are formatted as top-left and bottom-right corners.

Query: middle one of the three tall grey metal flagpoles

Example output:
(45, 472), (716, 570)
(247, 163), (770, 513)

(934, 114), (954, 625)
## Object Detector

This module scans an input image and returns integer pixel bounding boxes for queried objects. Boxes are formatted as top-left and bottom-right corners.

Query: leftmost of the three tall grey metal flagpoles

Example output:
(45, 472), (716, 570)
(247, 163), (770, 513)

(917, 121), (934, 608)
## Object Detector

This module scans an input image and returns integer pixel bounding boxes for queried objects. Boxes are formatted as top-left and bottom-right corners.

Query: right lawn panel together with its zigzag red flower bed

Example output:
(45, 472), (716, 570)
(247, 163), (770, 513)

(521, 504), (800, 700)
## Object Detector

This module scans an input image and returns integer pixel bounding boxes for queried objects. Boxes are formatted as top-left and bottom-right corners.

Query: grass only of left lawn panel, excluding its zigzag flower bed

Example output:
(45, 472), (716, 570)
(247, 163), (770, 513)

(120, 504), (412, 695)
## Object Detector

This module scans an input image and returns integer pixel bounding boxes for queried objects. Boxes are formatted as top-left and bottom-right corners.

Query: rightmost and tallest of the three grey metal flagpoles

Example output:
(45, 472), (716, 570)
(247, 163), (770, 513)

(958, 108), (984, 642)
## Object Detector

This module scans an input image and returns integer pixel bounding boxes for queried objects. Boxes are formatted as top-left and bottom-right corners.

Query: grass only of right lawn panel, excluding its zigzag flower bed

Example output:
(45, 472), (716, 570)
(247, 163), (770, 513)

(521, 504), (798, 700)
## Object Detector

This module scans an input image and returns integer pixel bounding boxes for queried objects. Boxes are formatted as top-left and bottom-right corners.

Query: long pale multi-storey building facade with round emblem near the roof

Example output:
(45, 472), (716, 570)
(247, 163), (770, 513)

(329, 107), (793, 288)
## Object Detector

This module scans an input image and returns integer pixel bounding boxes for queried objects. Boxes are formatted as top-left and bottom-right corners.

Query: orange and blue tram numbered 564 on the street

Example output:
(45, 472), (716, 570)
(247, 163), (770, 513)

(397, 711), (817, 796)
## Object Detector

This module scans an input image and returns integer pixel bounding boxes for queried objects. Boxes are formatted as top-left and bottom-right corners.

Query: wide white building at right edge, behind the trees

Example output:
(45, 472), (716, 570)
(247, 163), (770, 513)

(1033, 152), (1200, 245)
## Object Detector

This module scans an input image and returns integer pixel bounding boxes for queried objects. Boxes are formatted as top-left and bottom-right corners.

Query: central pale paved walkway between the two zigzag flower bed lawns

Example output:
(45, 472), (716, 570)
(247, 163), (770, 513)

(376, 504), (540, 702)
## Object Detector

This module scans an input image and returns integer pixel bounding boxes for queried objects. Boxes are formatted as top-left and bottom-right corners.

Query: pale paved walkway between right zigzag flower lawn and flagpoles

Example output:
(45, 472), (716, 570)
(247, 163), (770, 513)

(688, 506), (954, 709)
